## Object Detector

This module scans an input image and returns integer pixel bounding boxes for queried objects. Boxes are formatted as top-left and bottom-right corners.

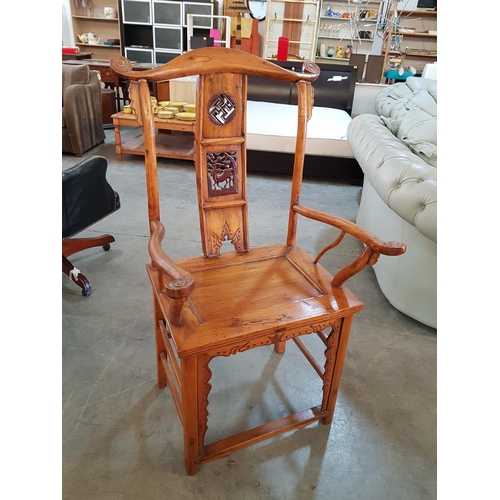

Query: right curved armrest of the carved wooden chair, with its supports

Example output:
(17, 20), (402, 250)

(293, 204), (406, 287)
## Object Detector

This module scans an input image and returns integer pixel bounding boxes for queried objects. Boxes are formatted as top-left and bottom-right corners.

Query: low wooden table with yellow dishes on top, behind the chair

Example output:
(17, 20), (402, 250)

(111, 111), (195, 161)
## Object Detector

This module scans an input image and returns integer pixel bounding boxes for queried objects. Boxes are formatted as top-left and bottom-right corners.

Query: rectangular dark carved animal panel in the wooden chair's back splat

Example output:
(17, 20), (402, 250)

(207, 151), (238, 197)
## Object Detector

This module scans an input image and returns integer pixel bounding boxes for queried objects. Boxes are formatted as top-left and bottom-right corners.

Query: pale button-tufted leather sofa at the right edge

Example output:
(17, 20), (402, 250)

(347, 77), (437, 328)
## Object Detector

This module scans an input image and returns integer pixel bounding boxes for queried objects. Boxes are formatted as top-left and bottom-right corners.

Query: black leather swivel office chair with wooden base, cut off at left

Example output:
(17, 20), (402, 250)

(62, 156), (120, 297)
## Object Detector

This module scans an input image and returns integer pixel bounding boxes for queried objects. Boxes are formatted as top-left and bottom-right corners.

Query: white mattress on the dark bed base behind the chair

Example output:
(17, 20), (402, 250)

(246, 101), (354, 158)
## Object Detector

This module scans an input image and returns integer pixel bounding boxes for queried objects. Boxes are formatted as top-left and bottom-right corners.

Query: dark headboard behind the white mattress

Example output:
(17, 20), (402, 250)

(248, 61), (357, 115)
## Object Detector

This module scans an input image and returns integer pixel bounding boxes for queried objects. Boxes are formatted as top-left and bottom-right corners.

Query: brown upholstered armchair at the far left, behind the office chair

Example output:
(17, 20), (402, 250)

(62, 64), (105, 156)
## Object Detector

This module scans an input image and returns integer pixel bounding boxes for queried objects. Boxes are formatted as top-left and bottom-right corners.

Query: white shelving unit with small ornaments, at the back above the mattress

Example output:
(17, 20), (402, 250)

(316, 0), (383, 64)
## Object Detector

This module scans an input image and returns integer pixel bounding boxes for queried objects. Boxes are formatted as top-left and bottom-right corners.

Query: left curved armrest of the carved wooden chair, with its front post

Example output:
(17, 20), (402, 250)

(148, 220), (195, 326)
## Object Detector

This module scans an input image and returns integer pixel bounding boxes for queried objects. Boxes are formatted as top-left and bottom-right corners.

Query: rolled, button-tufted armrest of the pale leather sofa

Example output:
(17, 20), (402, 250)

(347, 114), (437, 242)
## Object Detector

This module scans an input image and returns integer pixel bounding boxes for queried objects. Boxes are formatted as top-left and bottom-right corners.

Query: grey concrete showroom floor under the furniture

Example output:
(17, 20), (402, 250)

(62, 129), (437, 500)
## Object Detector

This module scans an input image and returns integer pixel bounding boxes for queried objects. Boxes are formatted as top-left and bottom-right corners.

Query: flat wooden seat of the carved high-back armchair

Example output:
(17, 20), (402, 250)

(147, 244), (363, 358)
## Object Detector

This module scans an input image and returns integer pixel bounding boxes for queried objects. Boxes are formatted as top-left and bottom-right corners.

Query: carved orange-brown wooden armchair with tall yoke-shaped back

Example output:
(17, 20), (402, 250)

(111, 47), (405, 475)
